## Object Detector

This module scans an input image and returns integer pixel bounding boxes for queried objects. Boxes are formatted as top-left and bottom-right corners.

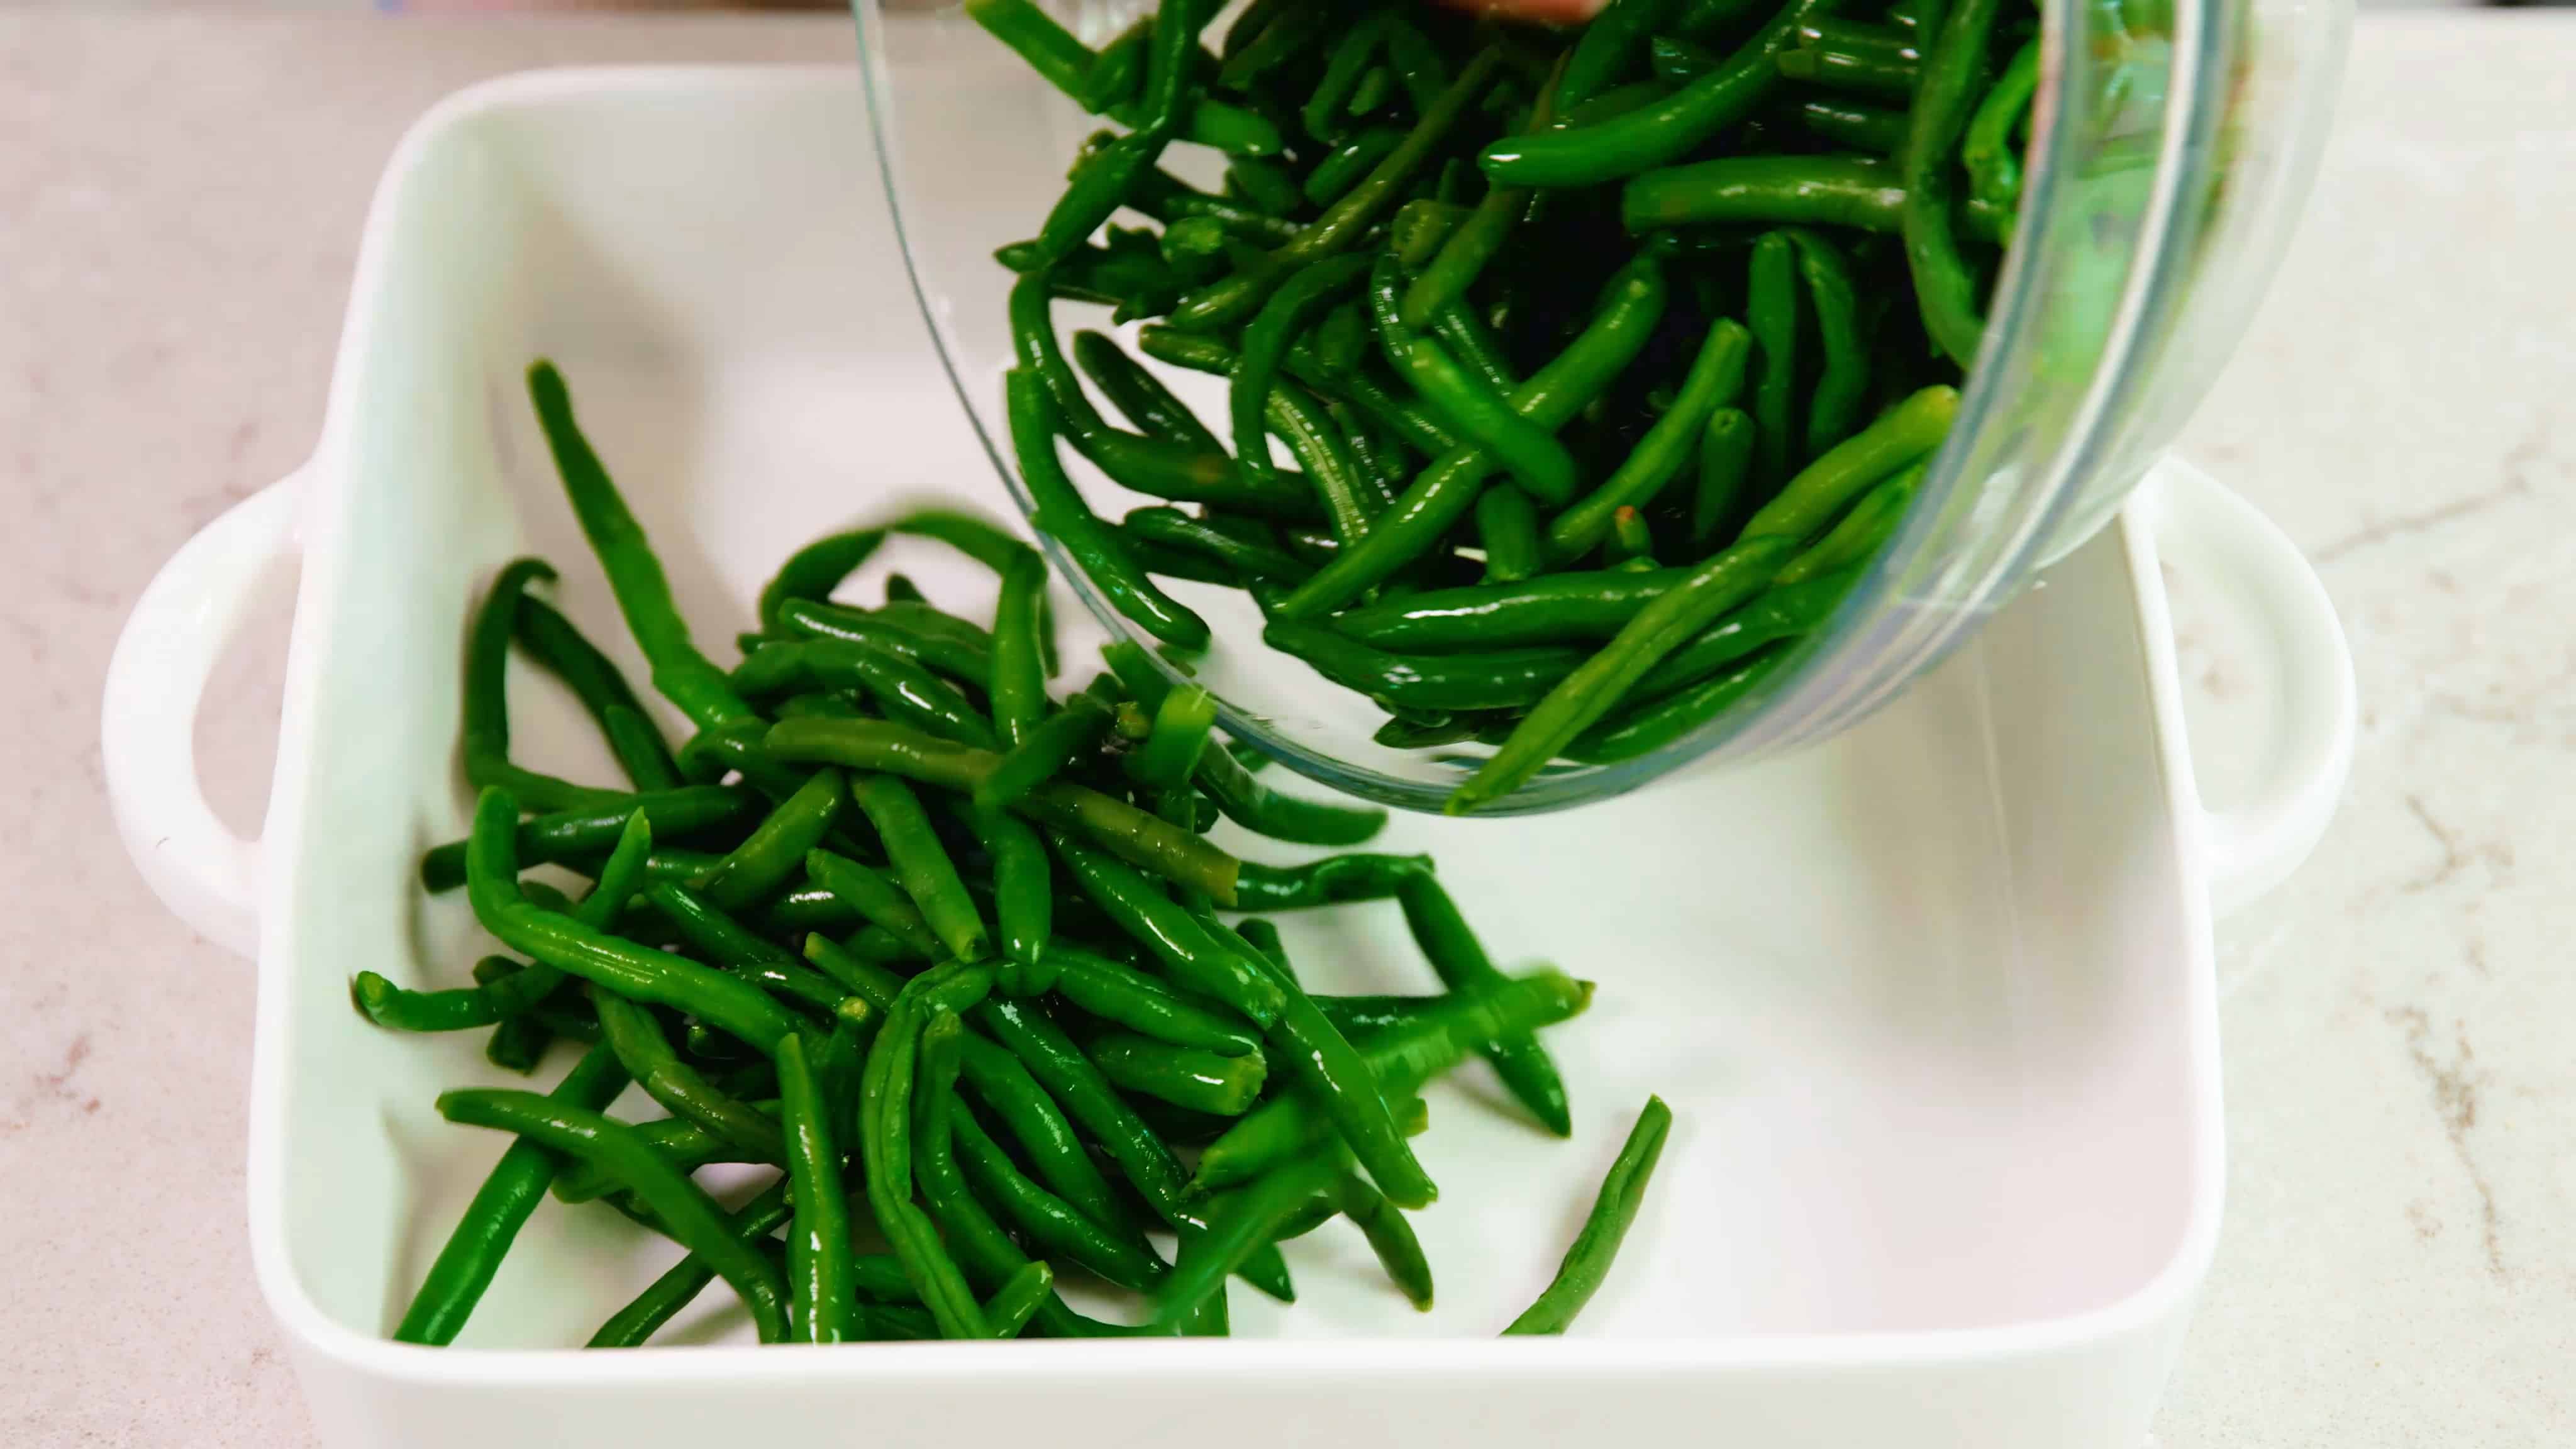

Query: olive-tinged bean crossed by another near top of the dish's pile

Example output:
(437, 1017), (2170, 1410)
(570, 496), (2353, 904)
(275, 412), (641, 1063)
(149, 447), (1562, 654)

(768, 719), (1241, 905)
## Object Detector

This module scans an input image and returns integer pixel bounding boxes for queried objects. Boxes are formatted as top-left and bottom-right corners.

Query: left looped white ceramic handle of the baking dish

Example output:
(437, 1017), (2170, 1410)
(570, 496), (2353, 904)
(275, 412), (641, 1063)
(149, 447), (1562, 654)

(98, 464), (309, 957)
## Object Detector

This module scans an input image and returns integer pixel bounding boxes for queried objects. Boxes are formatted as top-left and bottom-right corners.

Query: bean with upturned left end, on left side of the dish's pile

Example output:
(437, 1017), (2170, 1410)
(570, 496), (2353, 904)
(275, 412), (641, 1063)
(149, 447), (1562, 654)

(466, 789), (796, 1052)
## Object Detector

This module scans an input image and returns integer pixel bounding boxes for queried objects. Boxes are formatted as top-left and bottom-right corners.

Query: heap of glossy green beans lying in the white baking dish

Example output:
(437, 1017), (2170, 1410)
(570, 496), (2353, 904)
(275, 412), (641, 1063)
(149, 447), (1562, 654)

(376, 361), (1643, 1346)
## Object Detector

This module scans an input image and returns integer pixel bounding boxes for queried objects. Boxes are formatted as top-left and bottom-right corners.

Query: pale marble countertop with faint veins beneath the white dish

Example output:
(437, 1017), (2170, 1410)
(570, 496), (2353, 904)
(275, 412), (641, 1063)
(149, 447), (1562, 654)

(0, 10), (2576, 1449)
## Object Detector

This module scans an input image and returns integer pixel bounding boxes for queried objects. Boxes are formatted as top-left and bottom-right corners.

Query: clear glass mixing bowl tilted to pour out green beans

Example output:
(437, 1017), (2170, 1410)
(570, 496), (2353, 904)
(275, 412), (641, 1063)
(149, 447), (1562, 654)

(858, 0), (2352, 814)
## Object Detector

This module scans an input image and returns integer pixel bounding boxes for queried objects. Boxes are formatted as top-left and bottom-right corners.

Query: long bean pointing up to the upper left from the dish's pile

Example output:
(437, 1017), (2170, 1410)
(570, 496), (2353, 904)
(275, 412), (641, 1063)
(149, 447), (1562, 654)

(528, 358), (752, 727)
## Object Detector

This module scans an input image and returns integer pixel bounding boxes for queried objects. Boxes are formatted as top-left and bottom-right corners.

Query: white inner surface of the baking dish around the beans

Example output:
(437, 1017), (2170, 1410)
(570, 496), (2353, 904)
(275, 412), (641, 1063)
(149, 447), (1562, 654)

(260, 75), (2207, 1346)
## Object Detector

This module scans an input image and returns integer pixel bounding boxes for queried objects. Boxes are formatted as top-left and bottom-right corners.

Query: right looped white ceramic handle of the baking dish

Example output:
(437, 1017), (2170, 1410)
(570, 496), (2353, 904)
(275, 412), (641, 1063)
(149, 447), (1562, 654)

(2138, 457), (2355, 910)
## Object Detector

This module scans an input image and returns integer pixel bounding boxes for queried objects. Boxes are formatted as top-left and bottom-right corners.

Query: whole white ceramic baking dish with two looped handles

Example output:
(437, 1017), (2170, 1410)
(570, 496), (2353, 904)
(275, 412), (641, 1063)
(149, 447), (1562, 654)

(106, 70), (2352, 1449)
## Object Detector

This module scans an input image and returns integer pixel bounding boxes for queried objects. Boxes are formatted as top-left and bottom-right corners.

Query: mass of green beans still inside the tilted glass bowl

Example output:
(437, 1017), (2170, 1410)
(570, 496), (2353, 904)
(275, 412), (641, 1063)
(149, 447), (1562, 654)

(966, 0), (2038, 812)
